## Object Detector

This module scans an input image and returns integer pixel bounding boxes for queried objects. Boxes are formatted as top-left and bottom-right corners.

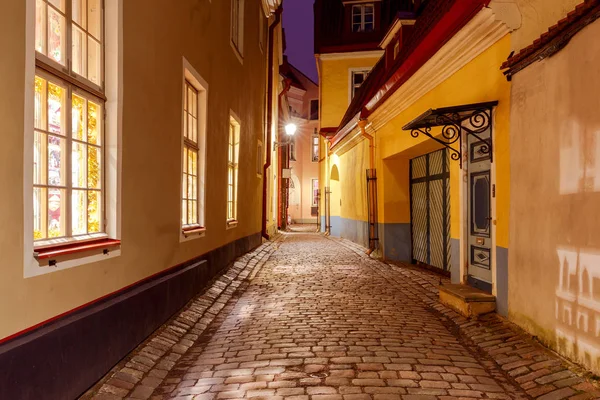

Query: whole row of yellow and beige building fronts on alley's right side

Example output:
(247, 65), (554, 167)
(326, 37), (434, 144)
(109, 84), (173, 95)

(317, 0), (600, 371)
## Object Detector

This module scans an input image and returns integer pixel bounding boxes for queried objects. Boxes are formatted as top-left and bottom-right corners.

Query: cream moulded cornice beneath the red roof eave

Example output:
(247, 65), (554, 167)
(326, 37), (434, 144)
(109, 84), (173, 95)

(369, 8), (510, 130)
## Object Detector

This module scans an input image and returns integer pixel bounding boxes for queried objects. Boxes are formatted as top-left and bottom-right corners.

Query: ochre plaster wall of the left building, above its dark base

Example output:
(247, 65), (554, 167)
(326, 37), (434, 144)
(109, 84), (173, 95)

(0, 0), (266, 338)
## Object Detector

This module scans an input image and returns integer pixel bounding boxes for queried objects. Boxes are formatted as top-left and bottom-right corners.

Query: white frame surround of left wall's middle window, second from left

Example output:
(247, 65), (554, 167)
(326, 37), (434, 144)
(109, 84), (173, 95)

(179, 57), (209, 243)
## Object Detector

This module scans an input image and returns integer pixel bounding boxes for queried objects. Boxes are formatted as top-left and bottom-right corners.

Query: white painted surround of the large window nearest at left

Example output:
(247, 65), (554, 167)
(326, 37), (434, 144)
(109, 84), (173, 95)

(23, 0), (123, 278)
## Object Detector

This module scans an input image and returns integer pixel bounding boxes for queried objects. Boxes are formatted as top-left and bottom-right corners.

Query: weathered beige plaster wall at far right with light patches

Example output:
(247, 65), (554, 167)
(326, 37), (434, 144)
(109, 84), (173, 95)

(509, 21), (600, 373)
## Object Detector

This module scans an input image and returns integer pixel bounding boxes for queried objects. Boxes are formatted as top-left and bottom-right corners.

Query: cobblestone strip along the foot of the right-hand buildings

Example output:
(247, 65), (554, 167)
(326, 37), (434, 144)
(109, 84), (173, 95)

(331, 238), (600, 400)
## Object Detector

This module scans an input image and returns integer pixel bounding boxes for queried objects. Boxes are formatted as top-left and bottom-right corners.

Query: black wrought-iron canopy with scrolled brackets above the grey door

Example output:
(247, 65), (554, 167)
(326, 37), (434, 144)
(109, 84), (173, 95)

(402, 101), (498, 168)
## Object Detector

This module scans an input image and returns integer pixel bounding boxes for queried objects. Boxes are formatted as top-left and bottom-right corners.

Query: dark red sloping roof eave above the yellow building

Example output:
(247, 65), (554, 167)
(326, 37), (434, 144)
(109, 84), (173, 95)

(332, 0), (490, 147)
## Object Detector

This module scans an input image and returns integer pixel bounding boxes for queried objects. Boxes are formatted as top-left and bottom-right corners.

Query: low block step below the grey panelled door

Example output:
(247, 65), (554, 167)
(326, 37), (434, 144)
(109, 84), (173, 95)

(439, 285), (496, 318)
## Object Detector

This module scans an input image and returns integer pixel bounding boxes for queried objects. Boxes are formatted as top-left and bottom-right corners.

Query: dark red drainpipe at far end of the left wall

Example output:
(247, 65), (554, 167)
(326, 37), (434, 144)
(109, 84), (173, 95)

(262, 6), (283, 240)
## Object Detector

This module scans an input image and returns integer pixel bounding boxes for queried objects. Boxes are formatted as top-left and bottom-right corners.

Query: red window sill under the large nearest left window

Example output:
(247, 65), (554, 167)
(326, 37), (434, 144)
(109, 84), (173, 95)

(33, 238), (121, 266)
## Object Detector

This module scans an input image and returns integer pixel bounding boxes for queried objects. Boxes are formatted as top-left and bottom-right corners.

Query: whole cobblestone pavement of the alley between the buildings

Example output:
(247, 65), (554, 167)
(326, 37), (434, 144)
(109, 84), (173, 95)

(85, 233), (600, 400)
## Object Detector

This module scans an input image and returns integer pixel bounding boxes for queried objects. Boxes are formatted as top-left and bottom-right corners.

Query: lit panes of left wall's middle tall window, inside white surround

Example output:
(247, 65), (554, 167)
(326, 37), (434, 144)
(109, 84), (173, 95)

(181, 80), (200, 231)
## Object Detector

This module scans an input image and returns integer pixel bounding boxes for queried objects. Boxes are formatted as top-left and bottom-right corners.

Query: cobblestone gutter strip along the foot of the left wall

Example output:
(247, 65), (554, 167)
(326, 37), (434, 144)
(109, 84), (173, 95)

(80, 236), (284, 400)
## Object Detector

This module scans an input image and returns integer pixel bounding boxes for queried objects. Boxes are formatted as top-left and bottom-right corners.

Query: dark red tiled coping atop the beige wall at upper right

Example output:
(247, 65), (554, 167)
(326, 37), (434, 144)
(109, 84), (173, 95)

(500, 0), (600, 76)
